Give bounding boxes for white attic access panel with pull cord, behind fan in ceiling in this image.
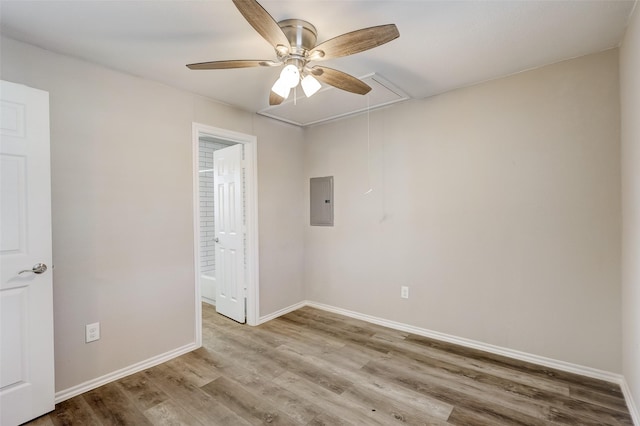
[258,73,409,126]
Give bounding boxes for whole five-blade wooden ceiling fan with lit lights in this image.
[187,0,400,105]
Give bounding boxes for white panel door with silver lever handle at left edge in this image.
[0,81,54,426]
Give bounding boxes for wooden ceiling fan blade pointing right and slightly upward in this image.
[309,24,400,61]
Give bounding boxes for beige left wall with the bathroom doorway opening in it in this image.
[1,39,303,391]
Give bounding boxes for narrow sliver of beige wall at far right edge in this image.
[620,3,640,415]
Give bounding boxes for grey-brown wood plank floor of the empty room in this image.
[29,305,632,426]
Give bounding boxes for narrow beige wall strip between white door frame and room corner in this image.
[255,116,304,316]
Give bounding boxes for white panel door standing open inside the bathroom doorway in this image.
[213,144,245,323]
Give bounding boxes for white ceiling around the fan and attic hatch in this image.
[0,0,635,112]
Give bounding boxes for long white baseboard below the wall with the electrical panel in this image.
[306,301,623,384]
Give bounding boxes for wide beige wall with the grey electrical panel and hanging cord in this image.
[305,50,621,372]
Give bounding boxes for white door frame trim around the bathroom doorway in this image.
[192,122,260,336]
